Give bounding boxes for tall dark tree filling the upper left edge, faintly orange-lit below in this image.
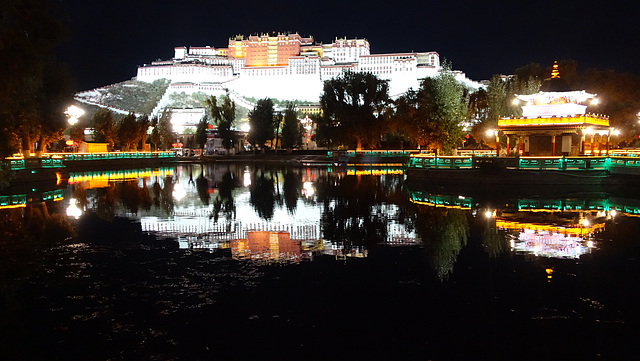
[0,0,73,157]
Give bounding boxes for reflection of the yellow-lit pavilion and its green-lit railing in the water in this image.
[410,191,624,258]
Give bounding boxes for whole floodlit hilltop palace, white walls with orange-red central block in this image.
[137,33,480,102]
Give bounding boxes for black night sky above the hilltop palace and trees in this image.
[50,0,640,90]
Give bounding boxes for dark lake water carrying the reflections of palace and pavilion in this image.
[0,165,640,360]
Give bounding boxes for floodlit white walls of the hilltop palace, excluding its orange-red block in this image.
[137,43,481,106]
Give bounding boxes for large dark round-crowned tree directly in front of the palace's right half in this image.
[316,72,390,150]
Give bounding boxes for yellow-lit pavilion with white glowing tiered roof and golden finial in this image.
[498,62,612,156]
